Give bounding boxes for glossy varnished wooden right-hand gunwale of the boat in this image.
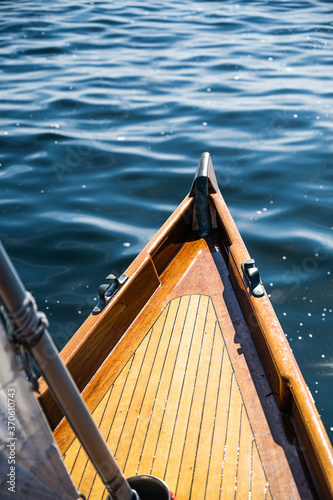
[210,189,333,499]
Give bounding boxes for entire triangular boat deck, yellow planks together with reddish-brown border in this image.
[55,236,313,500]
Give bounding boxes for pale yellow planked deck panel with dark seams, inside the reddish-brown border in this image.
[65,295,271,499]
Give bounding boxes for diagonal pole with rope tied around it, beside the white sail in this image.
[0,242,138,500]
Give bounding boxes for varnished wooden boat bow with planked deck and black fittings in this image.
[40,153,333,500]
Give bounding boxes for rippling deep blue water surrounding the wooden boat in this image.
[0,0,333,438]
